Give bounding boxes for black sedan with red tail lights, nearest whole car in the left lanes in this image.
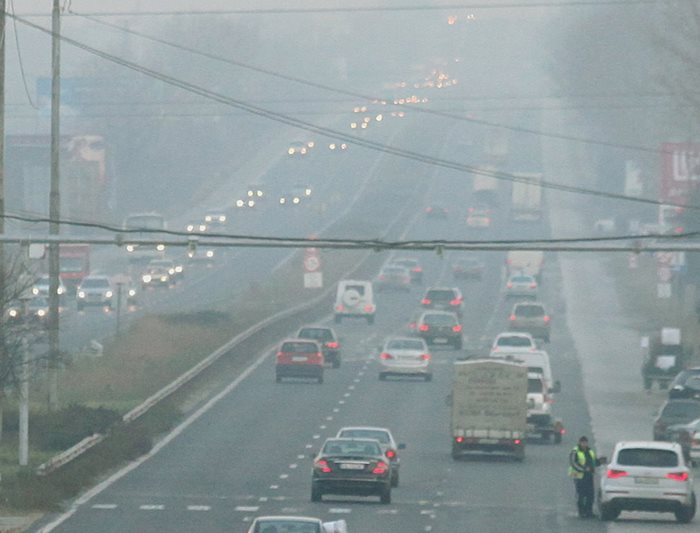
[311,439,391,504]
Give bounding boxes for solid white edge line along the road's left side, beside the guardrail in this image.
[39,340,272,533]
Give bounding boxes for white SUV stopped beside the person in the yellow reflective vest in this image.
[598,441,696,523]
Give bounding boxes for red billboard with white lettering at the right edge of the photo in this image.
[659,143,700,204]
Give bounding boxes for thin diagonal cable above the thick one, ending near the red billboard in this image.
[71,11,660,154]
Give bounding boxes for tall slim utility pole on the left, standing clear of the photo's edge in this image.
[48,0,61,411]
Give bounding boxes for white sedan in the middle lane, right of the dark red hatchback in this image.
[379,337,433,381]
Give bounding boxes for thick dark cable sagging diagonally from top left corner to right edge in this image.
[8,14,700,210]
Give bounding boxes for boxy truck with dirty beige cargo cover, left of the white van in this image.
[451,359,528,461]
